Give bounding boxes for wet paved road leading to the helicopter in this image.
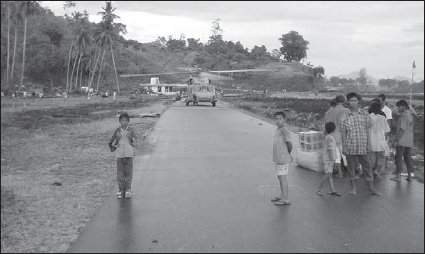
[69,99,424,252]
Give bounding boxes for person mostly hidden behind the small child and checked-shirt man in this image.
[324,94,350,178]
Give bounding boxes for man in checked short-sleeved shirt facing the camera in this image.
[340,92,382,196]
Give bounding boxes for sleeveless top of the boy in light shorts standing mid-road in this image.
[273,127,292,165]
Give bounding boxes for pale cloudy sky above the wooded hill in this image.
[41,1,424,82]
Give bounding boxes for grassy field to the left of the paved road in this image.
[1,96,173,253]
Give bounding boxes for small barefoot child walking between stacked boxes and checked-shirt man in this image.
[316,122,341,196]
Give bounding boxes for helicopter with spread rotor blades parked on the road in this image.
[120,67,270,107]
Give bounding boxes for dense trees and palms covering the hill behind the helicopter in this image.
[1,1,320,94]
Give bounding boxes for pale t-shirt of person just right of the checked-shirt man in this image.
[369,113,390,152]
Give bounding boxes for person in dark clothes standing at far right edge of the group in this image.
[390,100,413,182]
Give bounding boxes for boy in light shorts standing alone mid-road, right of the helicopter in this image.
[272,111,292,205]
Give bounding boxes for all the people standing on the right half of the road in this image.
[271,92,413,205]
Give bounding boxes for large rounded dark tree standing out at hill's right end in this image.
[279,31,310,62]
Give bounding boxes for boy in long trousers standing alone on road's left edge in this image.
[109,112,136,198]
